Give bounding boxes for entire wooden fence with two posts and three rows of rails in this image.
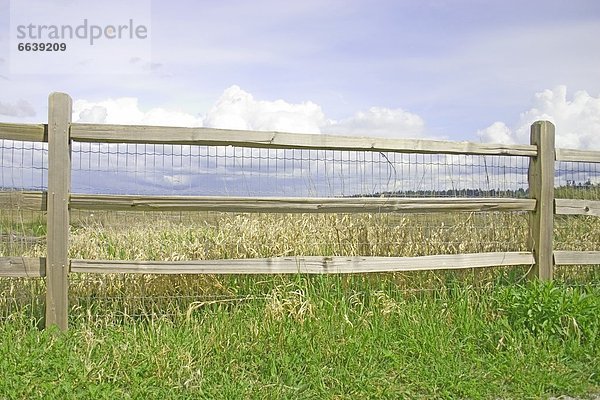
[0,93,600,329]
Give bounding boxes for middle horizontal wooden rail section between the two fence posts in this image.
[71,194,535,213]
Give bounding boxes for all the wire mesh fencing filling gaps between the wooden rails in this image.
[0,130,600,324]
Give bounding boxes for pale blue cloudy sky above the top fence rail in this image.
[0,0,600,148]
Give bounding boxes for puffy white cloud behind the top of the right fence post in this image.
[478,85,600,149]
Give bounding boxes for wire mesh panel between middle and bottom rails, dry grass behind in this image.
[70,212,528,261]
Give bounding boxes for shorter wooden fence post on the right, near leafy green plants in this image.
[529,121,555,281]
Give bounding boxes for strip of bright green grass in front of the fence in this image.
[0,276,600,399]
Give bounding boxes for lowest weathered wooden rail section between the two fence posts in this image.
[71,252,534,274]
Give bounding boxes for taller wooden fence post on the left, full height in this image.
[46,93,72,330]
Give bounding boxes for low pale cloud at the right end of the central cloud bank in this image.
[324,107,425,138]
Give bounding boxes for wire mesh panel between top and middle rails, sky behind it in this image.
[72,143,529,197]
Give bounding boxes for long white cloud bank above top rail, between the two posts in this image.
[73,85,425,141]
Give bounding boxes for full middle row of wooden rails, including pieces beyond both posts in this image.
[0,191,536,215]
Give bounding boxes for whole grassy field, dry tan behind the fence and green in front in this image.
[0,211,600,399]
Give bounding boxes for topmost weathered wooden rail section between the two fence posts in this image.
[71,124,537,156]
